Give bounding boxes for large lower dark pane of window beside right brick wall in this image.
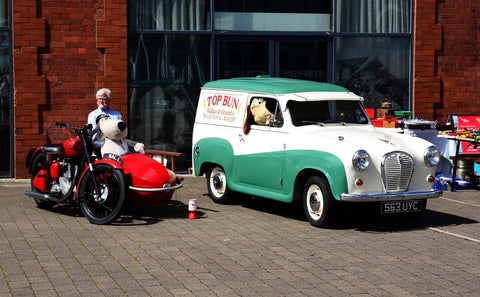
[336,37,410,110]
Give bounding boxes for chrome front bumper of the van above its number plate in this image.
[340,190,443,202]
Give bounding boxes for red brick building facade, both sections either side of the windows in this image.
[12,0,480,178]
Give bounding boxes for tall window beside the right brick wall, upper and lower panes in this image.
[335,0,411,110]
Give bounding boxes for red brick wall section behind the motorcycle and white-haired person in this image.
[12,0,128,178]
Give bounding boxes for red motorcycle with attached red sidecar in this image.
[25,122,183,224]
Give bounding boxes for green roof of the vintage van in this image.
[203,76,349,94]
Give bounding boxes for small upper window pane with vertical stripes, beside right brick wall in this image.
[337,0,410,33]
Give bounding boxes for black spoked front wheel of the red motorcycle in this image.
[79,164,127,225]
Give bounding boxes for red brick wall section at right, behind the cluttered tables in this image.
[413,0,480,121]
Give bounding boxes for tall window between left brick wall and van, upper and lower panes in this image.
[128,0,211,172]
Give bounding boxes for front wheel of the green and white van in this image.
[303,176,335,227]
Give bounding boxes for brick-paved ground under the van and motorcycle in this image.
[0,176,480,297]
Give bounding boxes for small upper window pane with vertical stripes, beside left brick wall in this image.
[128,0,210,30]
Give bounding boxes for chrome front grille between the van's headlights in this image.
[382,152,414,192]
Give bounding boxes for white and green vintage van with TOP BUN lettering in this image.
[192,77,442,227]
